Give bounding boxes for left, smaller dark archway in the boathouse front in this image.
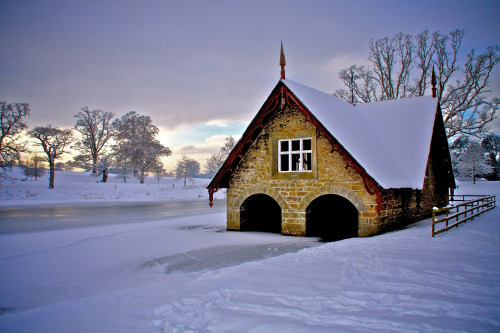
[240,194,281,233]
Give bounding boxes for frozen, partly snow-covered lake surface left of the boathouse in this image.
[0,200,320,326]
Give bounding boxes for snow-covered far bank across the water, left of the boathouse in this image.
[0,168,225,206]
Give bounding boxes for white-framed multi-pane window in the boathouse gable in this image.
[278,138,312,172]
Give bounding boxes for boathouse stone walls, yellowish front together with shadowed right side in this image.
[227,108,448,236]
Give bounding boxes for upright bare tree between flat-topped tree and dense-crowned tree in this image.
[74,106,115,175]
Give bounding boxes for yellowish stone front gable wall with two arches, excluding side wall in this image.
[227,108,379,236]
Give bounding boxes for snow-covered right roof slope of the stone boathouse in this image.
[282,79,438,189]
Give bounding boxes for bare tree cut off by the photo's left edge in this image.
[0,101,30,165]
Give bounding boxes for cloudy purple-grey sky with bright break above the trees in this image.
[0,0,500,170]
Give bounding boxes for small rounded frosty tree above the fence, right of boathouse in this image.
[457,141,492,184]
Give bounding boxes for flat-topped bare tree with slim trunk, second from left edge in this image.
[28,125,73,188]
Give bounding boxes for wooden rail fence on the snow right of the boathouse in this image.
[432,194,496,237]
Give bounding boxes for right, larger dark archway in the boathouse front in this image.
[306,194,358,242]
